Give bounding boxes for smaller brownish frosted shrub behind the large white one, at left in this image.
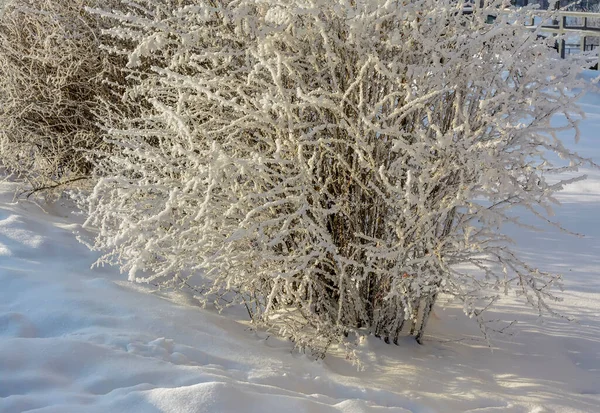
[0,0,124,194]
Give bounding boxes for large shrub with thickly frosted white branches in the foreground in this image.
[87,0,596,351]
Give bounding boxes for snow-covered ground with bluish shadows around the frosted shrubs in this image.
[0,96,600,413]
